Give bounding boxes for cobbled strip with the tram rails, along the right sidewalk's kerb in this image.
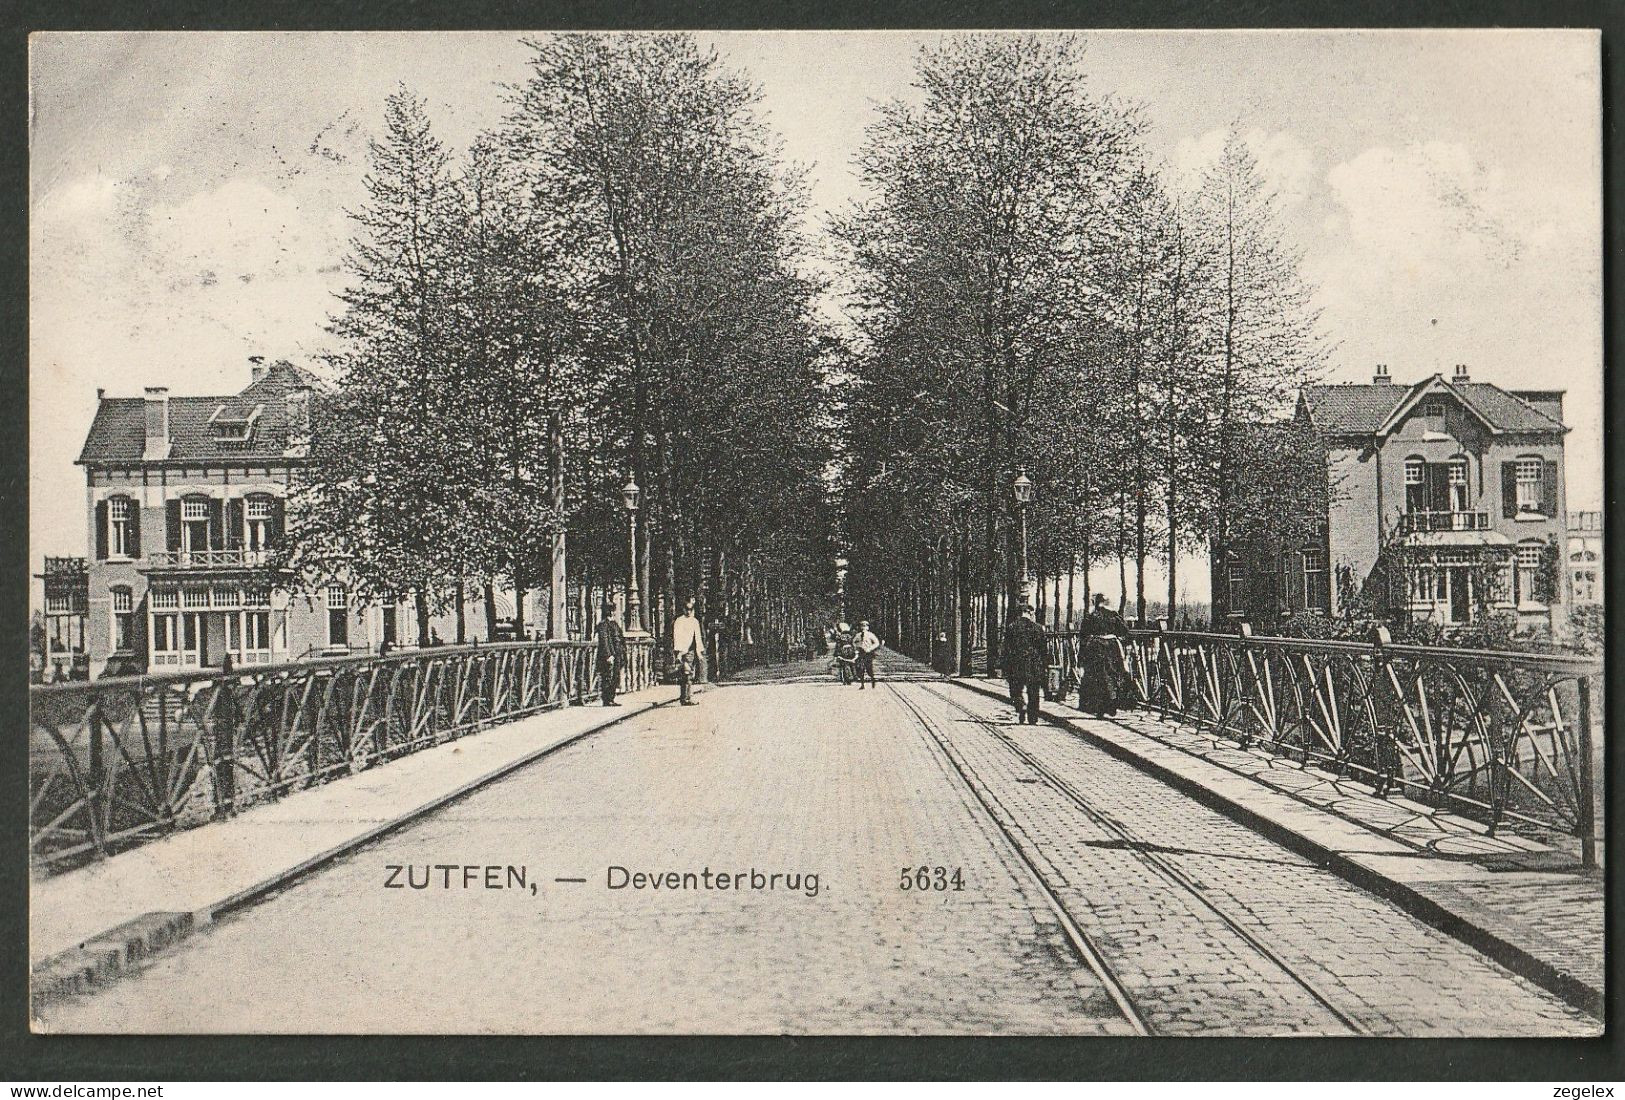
[904,684,1601,1037]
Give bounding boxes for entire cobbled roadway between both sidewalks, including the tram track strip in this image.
[42,660,1597,1035]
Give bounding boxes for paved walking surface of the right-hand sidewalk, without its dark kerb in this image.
[1098,708,1607,990]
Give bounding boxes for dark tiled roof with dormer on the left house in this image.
[78,362,322,465]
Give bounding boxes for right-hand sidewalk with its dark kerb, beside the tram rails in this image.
[954,679,1604,1017]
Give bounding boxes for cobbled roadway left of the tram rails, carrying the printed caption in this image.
[34,656,1128,1035]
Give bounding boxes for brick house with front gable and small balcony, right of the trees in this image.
[1222,366,1571,630]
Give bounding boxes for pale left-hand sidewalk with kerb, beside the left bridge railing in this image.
[29,686,689,998]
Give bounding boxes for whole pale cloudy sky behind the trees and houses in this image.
[29,31,1602,598]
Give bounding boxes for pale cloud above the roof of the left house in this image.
[29,171,349,565]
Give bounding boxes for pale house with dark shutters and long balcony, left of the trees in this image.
[78,359,425,676]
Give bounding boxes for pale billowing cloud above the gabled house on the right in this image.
[1307,134,1602,507]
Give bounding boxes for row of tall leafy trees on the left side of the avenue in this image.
[288,34,835,640]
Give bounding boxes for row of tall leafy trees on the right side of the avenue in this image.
[837,36,1324,669]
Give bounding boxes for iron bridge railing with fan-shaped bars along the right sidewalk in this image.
[1050,629,1602,864]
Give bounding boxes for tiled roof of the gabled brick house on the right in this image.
[1302,374,1568,435]
